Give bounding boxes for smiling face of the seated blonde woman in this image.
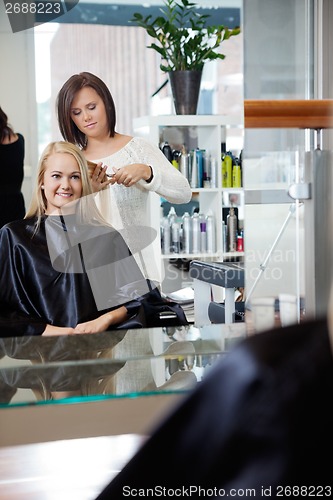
[42,153,82,215]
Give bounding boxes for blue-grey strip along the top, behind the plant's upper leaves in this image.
[57,0,241,28]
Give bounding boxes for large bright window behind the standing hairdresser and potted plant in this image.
[35,0,243,148]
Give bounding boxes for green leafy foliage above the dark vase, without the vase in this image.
[131,0,240,72]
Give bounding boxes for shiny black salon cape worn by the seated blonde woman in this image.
[0,216,149,337]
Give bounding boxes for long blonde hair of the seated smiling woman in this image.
[24,141,106,232]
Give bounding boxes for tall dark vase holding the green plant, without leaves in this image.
[169,70,202,115]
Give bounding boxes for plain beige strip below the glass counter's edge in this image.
[0,392,186,446]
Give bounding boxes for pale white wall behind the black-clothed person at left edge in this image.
[0,2,38,205]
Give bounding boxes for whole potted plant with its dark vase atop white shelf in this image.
[132,0,240,114]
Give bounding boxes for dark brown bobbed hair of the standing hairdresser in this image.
[56,71,116,148]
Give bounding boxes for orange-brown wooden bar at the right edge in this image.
[244,99,333,129]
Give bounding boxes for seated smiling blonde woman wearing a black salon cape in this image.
[0,141,147,336]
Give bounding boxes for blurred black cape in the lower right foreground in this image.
[97,320,333,500]
